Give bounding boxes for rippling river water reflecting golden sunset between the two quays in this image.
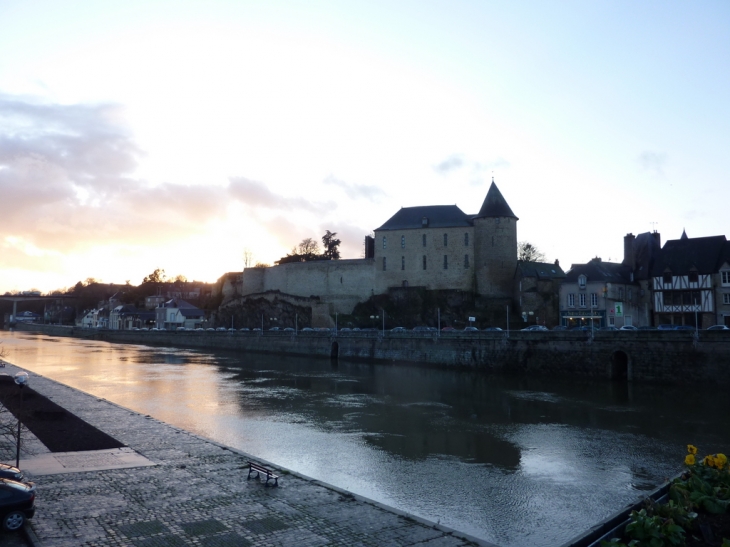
[0,332,730,547]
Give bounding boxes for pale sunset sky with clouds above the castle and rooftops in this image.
[0,0,730,293]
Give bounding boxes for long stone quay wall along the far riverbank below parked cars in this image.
[18,324,730,385]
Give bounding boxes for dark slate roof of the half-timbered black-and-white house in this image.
[652,236,730,277]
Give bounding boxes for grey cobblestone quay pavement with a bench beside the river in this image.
[0,365,488,547]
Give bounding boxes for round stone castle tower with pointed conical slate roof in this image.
[473,179,519,298]
